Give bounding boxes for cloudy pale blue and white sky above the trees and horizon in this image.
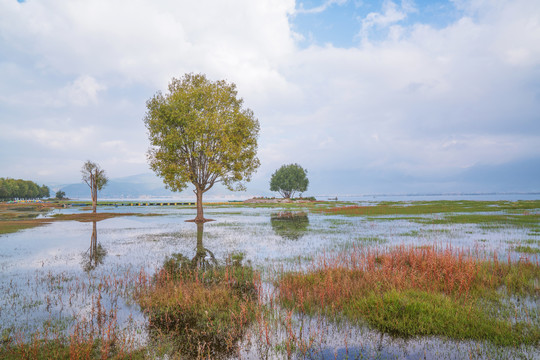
[0,0,540,194]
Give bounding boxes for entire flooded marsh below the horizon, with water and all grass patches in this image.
[0,201,540,359]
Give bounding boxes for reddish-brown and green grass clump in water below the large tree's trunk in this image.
[136,253,260,359]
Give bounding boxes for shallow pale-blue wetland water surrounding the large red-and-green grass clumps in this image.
[0,201,540,359]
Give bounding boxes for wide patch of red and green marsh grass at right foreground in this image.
[276,246,540,346]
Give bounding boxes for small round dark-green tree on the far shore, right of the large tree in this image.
[270,164,309,199]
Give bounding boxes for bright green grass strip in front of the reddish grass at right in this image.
[343,289,528,345]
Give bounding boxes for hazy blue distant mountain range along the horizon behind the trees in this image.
[50,158,540,200]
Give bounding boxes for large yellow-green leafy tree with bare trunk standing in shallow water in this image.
[144,74,259,222]
